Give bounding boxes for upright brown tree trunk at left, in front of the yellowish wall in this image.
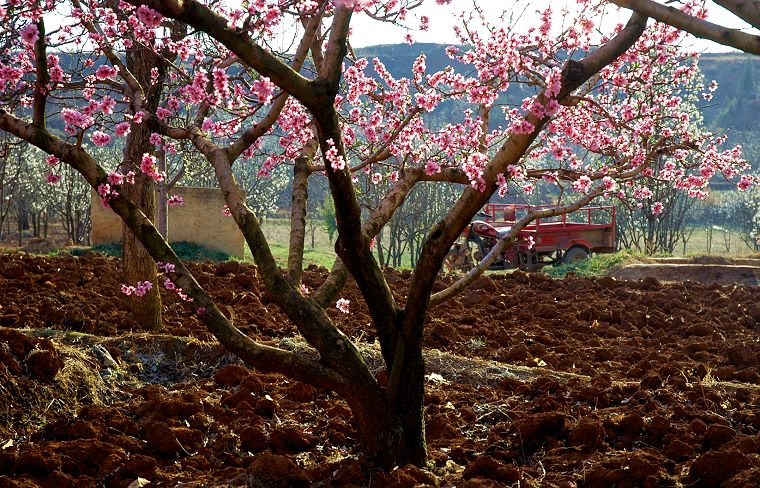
[122,43,165,331]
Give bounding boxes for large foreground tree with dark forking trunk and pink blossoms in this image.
[0,0,752,468]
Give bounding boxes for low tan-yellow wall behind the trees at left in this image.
[92,187,245,258]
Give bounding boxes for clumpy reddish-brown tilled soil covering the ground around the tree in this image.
[0,254,760,488]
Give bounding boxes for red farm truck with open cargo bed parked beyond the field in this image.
[445,203,616,271]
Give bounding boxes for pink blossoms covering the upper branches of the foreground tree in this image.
[0,0,757,254]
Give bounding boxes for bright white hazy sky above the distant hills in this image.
[351,0,748,52]
